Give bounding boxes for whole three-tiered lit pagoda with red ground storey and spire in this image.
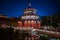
[18,3,41,29]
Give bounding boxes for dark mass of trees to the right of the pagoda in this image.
[42,13,60,28]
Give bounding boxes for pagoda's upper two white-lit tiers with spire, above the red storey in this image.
[21,3,39,20]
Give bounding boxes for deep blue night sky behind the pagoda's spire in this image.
[0,0,60,17]
